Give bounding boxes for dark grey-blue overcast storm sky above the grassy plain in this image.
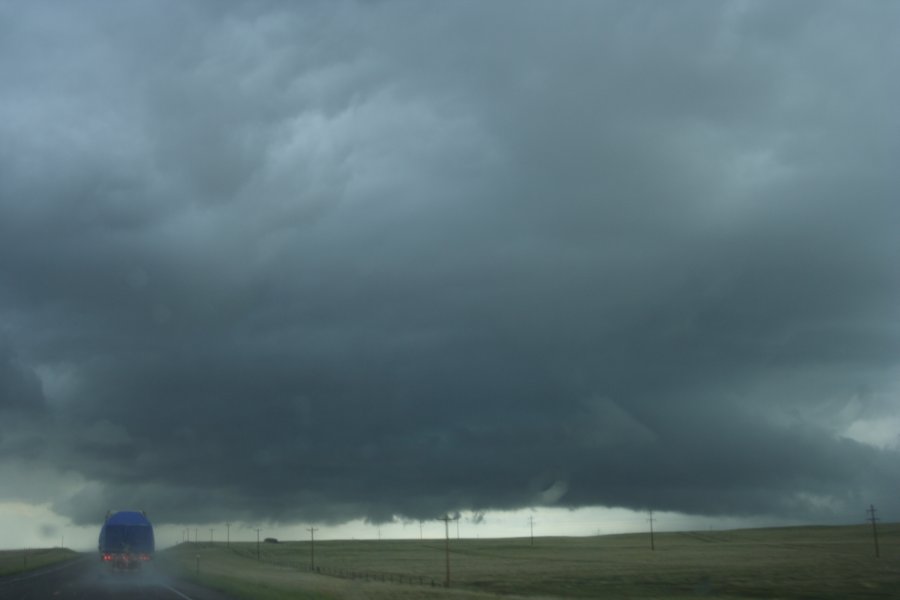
[0,0,900,544]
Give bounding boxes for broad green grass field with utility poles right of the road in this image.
[157,524,900,600]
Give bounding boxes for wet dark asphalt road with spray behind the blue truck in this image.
[0,554,232,600]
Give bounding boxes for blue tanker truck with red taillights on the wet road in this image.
[98,510,154,571]
